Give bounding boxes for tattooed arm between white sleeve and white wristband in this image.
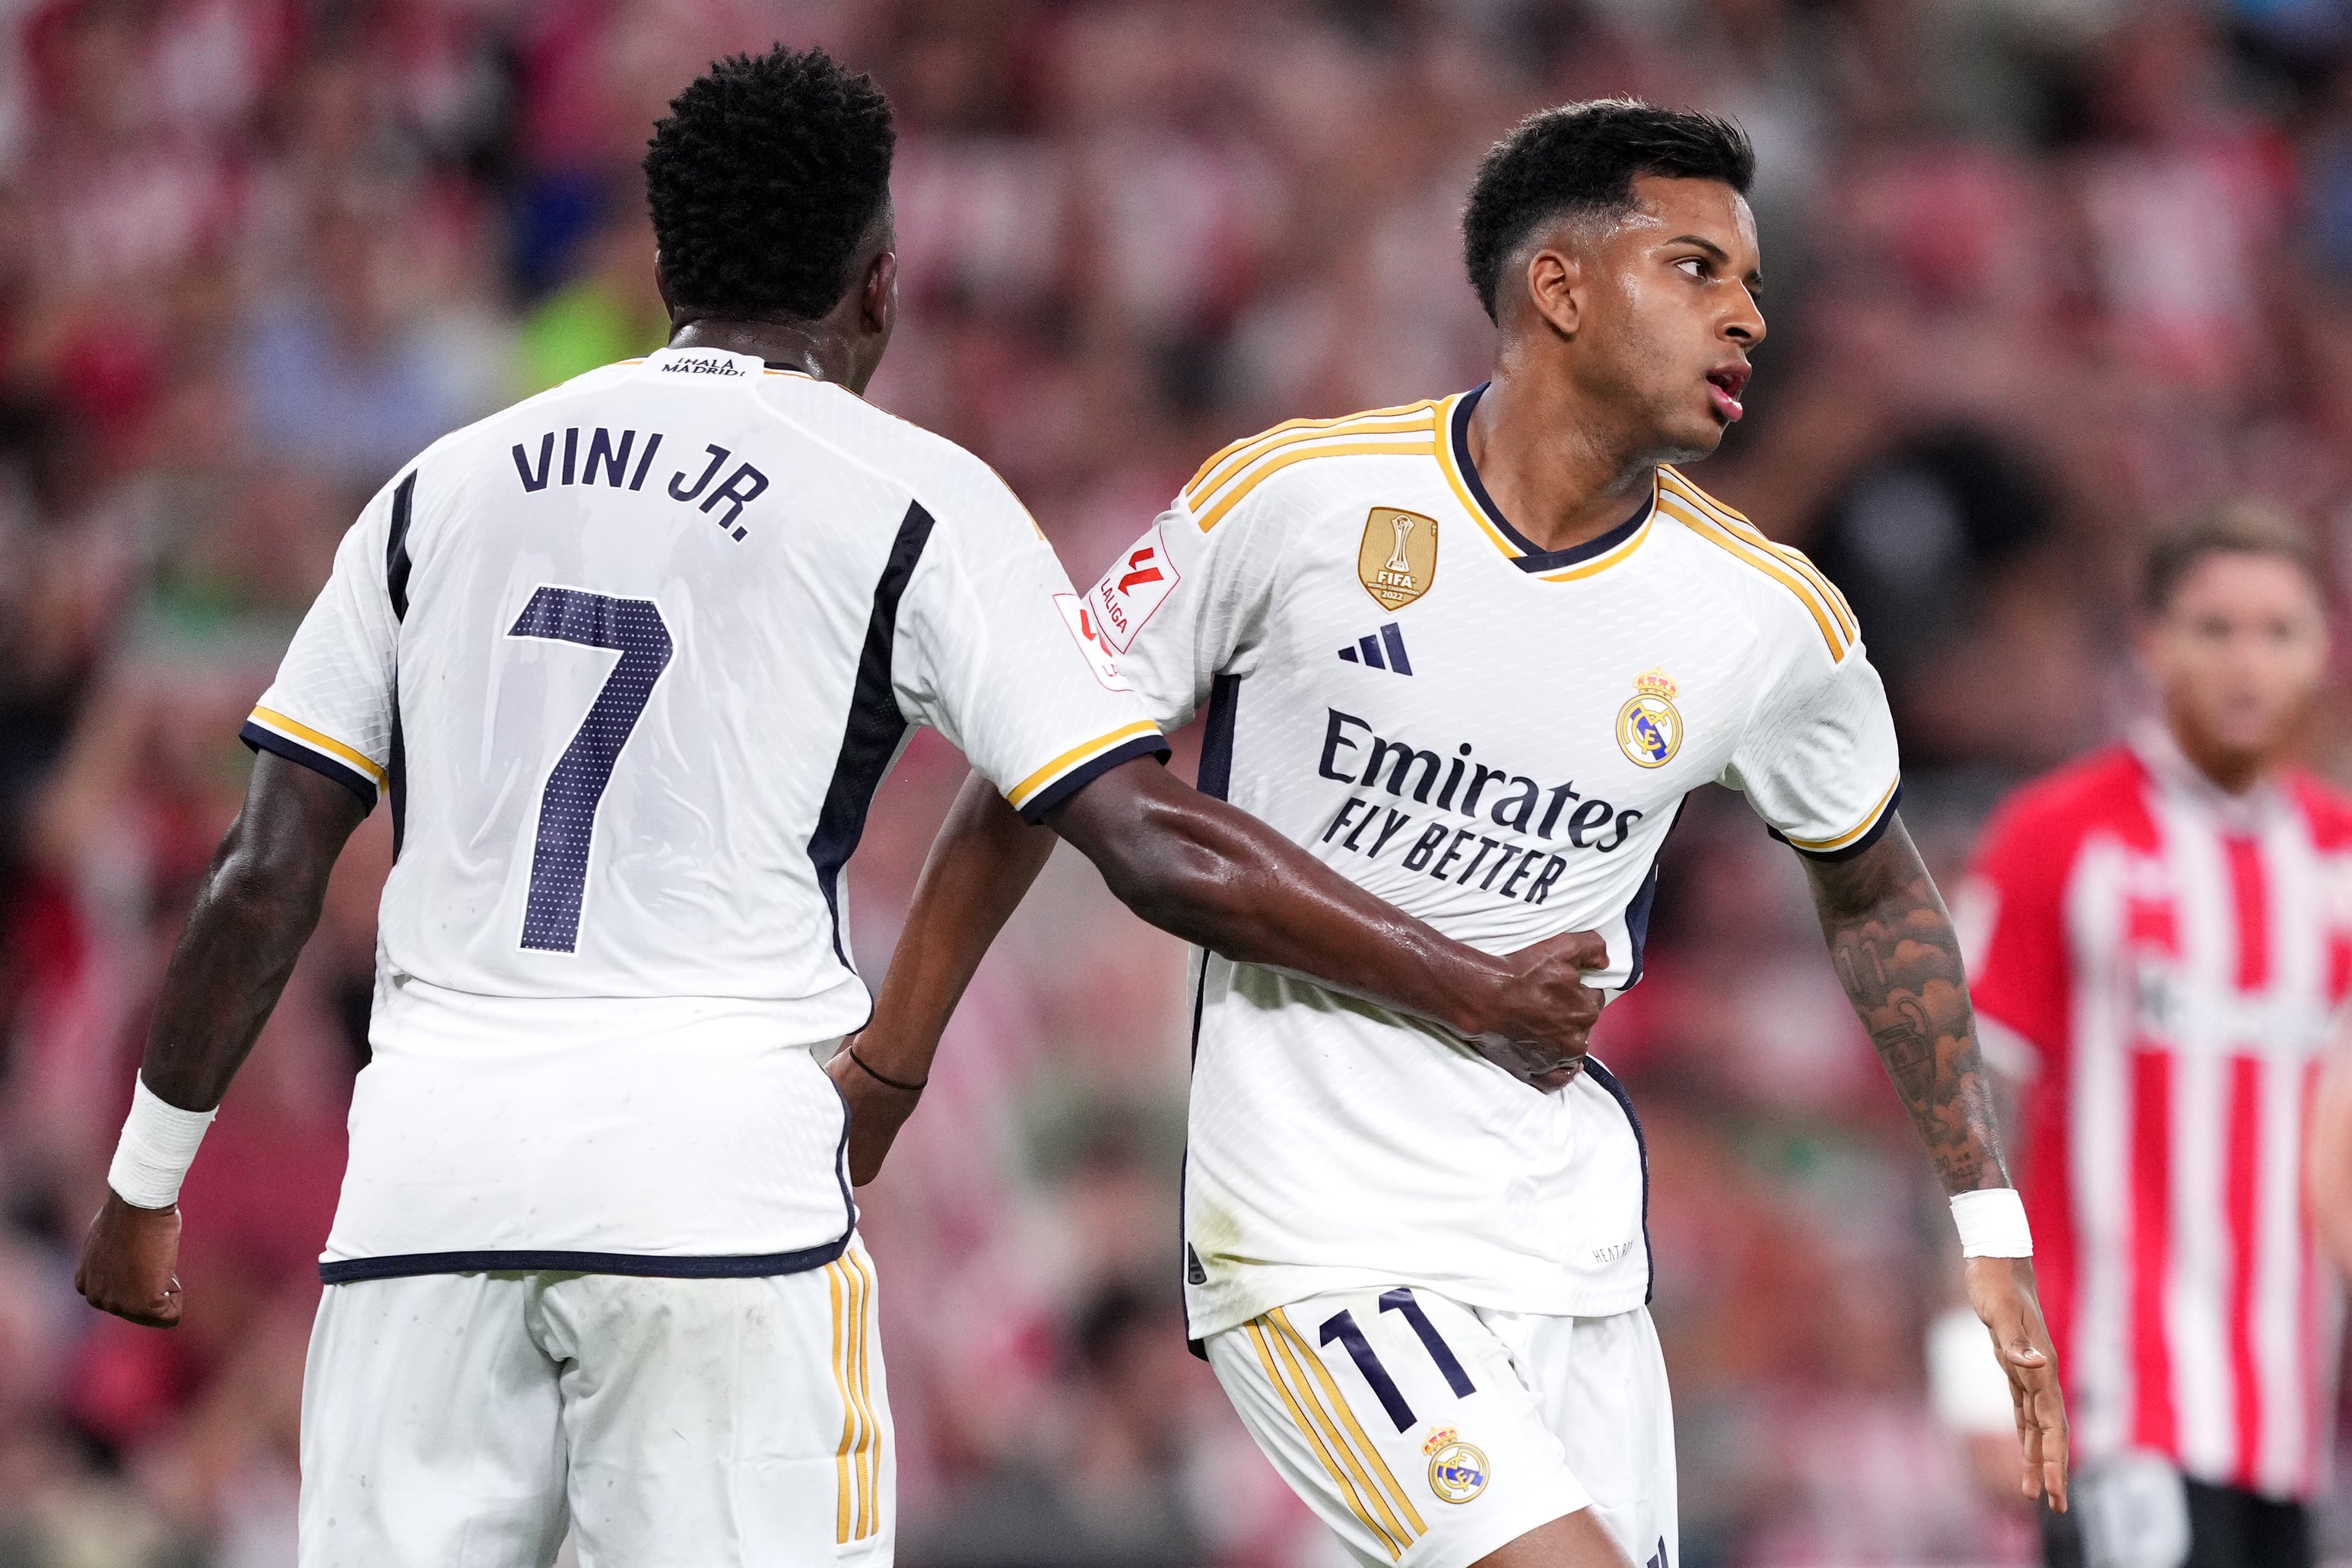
[1806,823,2006,1192]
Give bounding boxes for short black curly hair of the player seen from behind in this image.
[644,45,899,319]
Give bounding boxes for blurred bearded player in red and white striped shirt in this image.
[1954,503,2352,1568]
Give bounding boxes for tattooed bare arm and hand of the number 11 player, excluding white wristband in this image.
[1804,818,2068,1509]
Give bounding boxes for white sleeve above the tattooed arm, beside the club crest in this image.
[1722,637,1903,860]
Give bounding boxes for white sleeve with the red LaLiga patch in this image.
[1084,496,1282,728]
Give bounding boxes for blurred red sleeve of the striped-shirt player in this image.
[1954,808,2074,1077]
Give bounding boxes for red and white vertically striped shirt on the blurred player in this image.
[1962,731,2352,1497]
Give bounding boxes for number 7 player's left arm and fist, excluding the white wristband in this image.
[73,752,367,1328]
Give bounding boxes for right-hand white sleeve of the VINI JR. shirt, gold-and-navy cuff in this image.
[891,475,1169,821]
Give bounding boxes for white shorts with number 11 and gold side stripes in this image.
[1209,1286,1681,1568]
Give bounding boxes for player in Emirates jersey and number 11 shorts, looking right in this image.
[852,101,2065,1568]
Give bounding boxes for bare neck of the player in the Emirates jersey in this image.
[1470,369,1658,552]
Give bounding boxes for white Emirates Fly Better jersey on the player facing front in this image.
[1082,392,1896,1338]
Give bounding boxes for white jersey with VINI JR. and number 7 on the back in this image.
[245,351,1162,1284]
